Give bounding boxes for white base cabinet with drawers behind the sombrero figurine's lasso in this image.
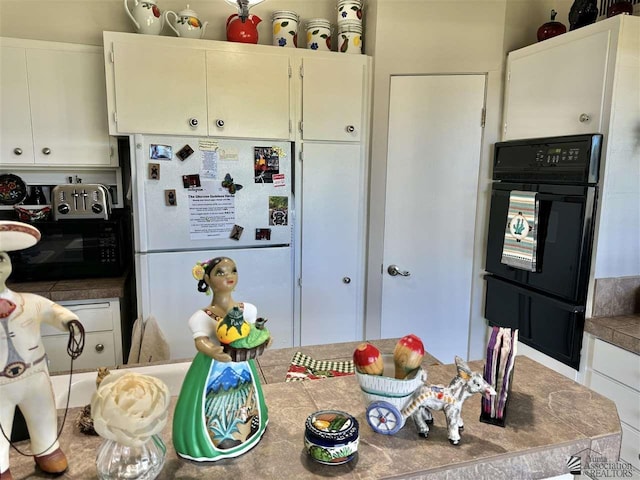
[41,299,122,372]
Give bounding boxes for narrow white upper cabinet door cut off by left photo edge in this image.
[0,46,33,165]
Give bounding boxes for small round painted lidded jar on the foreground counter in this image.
[304,410,359,465]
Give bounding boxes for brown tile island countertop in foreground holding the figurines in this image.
[11,340,621,480]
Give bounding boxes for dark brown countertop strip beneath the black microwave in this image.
[7,275,127,302]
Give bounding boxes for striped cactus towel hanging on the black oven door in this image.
[501,190,538,272]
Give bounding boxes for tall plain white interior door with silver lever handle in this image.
[381,75,485,363]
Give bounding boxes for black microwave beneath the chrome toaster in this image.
[9,209,132,282]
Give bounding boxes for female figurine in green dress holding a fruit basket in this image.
[173,257,271,461]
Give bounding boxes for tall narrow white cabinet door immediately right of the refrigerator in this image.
[300,143,365,345]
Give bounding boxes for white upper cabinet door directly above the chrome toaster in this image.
[27,49,111,166]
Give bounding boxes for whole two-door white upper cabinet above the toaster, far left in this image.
[0,39,117,167]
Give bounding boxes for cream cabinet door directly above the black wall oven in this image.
[503,31,610,140]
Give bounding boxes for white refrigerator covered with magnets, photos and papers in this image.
[131,135,294,359]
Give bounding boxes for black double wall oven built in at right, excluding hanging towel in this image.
[485,134,602,370]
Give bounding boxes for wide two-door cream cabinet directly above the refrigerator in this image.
[104,32,292,140]
